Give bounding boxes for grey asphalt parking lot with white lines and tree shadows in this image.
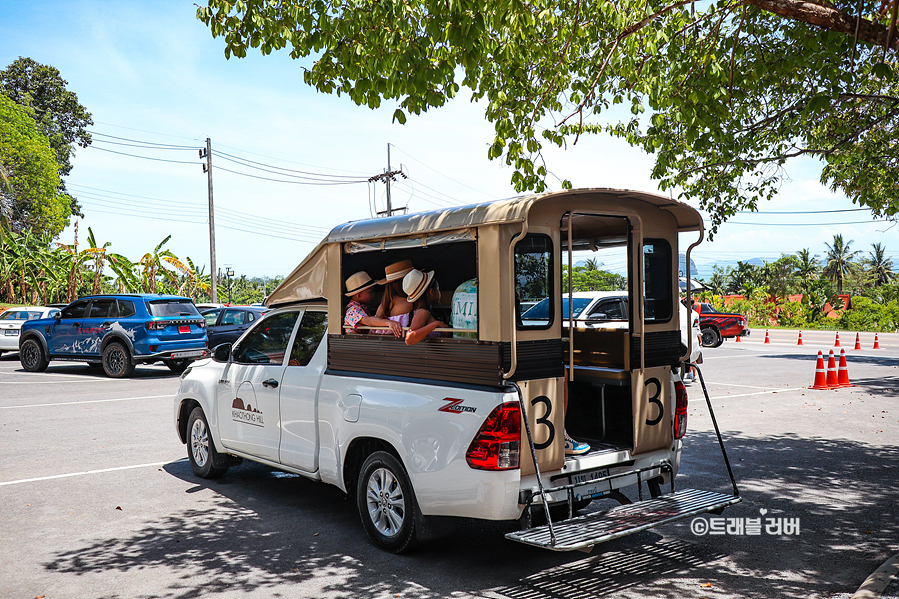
[0,330,899,599]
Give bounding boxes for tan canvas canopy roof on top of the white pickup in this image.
[266,188,703,306]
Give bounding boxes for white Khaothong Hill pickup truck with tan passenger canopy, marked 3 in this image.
[174,190,740,552]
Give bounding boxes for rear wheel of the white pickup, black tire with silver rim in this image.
[356,451,418,553]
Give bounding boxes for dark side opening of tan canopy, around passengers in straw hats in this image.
[341,240,478,338]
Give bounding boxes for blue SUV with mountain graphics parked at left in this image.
[19,294,208,378]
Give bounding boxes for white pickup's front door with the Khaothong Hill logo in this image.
[216,312,298,462]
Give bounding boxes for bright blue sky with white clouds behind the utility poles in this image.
[0,0,899,277]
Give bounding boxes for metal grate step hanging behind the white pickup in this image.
[506,489,741,551]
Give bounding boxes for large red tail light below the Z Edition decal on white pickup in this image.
[465,403,521,470]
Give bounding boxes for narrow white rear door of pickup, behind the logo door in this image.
[281,307,328,472]
